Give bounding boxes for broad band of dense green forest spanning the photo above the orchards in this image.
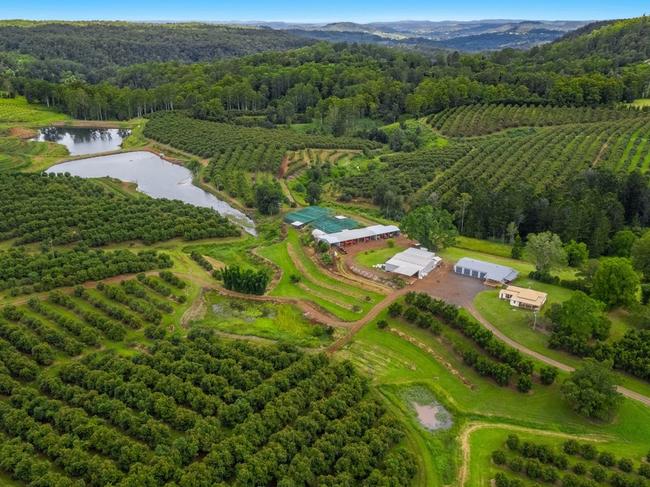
[0,18,650,123]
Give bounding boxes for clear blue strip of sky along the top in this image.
[0,0,650,22]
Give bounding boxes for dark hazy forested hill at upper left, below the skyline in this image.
[0,21,310,81]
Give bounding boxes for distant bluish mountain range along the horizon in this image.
[233,19,589,51]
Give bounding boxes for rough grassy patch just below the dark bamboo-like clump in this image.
[195,292,330,347]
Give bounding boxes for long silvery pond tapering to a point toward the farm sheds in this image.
[47,151,255,235]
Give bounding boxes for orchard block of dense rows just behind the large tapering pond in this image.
[144,113,377,173]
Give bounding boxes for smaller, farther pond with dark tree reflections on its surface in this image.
[33,127,131,156]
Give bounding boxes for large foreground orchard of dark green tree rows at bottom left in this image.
[0,310,415,487]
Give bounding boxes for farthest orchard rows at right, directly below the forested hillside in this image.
[428,104,650,137]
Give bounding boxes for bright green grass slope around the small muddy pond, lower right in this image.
[340,314,650,487]
